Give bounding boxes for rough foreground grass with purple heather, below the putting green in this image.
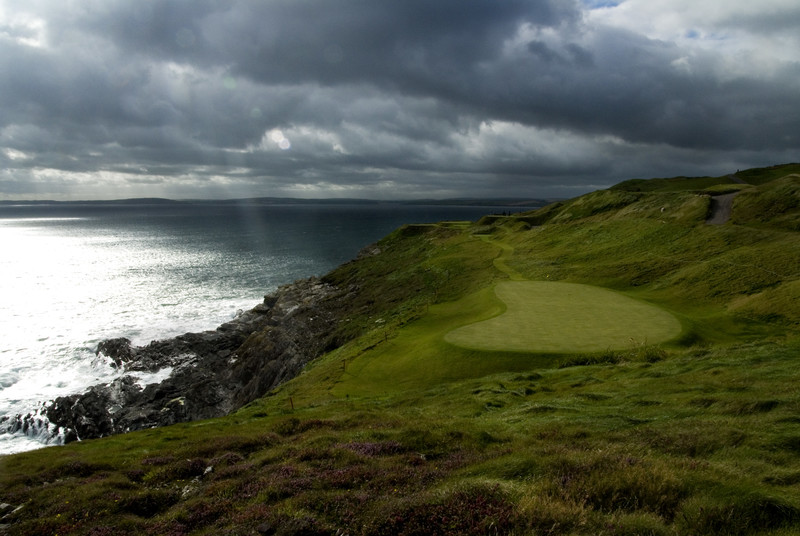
[0,343,800,535]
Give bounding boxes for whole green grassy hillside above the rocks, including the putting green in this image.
[0,165,800,535]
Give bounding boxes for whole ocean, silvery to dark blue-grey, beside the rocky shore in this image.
[0,203,506,454]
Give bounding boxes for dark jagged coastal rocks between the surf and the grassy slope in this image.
[46,278,348,442]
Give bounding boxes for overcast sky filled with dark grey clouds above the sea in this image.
[0,0,800,199]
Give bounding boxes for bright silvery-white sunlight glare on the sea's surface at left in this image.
[0,220,258,422]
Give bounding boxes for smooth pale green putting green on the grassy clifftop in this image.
[445,281,681,353]
